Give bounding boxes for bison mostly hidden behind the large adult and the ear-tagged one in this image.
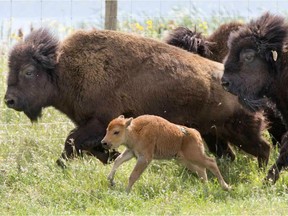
[165,22,287,147]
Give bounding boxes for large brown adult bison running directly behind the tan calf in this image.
[5,29,270,165]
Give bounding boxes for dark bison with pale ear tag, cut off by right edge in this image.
[222,13,288,182]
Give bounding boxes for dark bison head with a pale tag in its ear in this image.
[222,13,288,111]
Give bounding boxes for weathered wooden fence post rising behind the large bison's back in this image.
[105,0,118,30]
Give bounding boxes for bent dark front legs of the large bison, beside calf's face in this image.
[57,120,119,166]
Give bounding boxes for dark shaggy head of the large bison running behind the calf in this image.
[5,29,59,121]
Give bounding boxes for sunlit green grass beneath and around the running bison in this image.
[0,30,288,215]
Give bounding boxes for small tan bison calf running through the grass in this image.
[101,115,230,192]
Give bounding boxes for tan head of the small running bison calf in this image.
[101,115,133,149]
